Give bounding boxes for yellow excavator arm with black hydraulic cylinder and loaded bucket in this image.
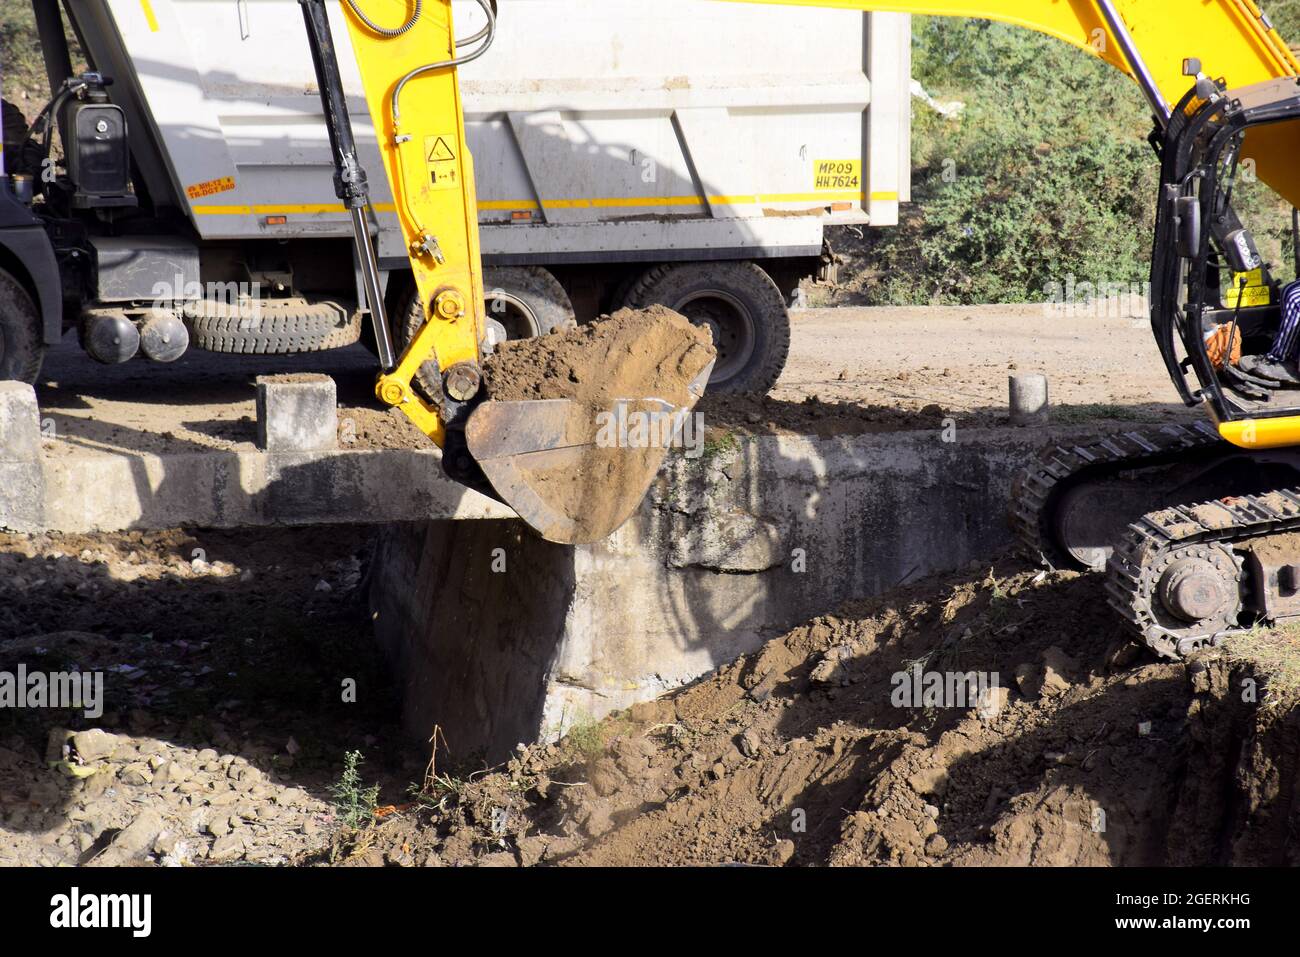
[300,0,714,544]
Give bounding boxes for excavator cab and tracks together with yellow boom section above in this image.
[761,0,1300,657]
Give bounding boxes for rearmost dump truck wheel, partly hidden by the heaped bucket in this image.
[625,263,790,394]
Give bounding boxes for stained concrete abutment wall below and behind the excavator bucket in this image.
[372,429,1093,759]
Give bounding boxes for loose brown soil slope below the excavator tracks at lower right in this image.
[325,562,1297,865]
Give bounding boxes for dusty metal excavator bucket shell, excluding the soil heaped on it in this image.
[465,358,714,545]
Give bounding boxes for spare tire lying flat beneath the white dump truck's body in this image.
[182,298,361,355]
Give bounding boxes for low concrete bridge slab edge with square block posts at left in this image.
[0,376,515,533]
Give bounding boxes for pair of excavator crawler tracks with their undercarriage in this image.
[1011,423,1300,657]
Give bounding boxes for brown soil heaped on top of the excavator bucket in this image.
[484,306,716,408]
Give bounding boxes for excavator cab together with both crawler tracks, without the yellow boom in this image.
[1013,27,1300,657]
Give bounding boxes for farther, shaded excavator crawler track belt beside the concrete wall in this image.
[1010,421,1230,568]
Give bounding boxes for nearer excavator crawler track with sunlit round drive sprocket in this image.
[1106,488,1300,658]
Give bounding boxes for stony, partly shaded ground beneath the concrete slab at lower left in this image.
[0,528,423,865]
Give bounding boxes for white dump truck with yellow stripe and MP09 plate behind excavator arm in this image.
[0,0,910,391]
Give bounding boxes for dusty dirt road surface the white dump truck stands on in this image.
[30,306,1187,460]
